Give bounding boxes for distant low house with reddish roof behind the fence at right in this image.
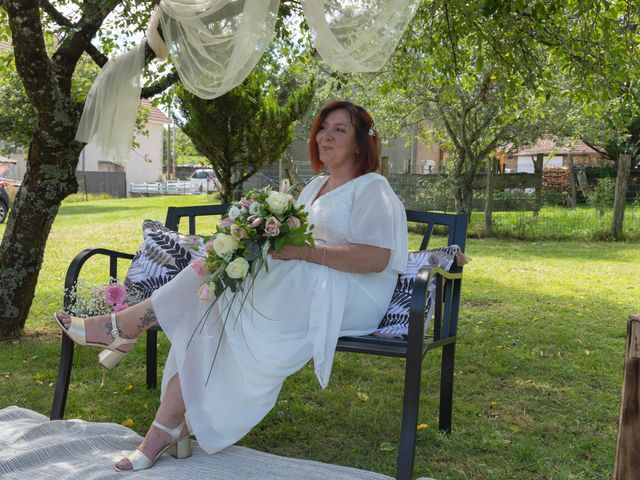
[499,137,613,173]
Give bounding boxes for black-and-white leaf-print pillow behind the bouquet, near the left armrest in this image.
[124,220,205,300]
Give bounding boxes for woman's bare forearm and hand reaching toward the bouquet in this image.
[271,243,391,273]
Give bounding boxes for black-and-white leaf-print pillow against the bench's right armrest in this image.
[373,245,460,338]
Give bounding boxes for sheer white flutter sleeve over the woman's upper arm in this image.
[347,176,408,273]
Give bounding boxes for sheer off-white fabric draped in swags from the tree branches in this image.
[76,0,419,164]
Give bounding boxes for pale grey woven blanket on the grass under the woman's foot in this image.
[0,407,436,480]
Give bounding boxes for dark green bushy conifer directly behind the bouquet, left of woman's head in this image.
[175,66,315,202]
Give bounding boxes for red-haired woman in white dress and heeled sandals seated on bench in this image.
[56,101,407,470]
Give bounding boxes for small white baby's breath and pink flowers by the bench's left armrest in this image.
[67,281,140,317]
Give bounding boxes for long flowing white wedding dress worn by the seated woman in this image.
[152,173,407,453]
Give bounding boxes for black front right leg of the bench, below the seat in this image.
[396,355,422,480]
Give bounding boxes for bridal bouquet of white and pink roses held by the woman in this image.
[191,186,313,302]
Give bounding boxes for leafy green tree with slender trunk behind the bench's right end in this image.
[356,0,549,211]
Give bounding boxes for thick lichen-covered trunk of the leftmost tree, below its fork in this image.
[0,130,82,338]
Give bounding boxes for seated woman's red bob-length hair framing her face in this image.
[309,100,380,177]
